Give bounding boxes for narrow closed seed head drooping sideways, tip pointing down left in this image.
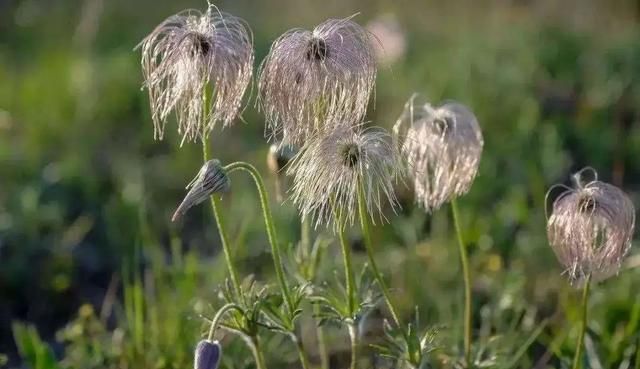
[171,159,231,221]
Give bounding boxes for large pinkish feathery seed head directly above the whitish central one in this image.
[258,17,376,145]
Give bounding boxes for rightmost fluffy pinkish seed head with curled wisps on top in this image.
[547,168,635,284]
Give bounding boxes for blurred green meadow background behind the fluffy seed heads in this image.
[0,0,640,368]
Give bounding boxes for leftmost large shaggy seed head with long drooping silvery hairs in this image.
[138,5,254,142]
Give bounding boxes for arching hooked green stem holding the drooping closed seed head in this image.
[225,161,293,314]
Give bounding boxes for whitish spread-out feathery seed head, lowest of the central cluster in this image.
[287,126,401,228]
